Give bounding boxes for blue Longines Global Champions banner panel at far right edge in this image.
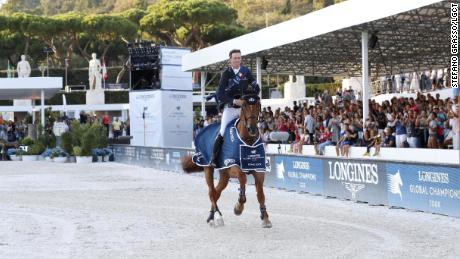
[386,163,460,217]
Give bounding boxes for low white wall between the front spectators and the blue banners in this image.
[266,144,460,165]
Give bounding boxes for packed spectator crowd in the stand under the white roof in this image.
[194,90,459,156]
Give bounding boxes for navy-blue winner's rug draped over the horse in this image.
[193,118,265,172]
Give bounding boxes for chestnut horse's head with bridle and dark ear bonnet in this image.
[241,94,260,137]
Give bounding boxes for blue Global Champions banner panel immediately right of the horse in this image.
[267,156,323,194]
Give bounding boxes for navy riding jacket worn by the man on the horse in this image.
[216,66,260,108]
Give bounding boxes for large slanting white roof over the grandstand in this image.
[182,0,450,76]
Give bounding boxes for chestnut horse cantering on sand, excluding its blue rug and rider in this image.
[182,95,272,228]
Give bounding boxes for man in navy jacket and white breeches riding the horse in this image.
[210,49,260,167]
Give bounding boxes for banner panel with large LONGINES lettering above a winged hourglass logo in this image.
[323,158,388,205]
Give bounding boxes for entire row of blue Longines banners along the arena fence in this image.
[114,145,460,217]
